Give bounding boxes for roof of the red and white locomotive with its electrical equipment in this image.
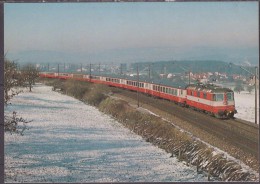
[186,83,233,93]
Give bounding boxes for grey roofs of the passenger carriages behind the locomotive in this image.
[93,74,188,89]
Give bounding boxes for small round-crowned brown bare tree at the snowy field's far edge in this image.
[21,64,39,92]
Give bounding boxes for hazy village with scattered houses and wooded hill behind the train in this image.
[18,61,259,93]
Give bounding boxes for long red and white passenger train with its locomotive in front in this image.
[39,72,237,119]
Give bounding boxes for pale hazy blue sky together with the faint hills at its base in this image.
[4,2,259,63]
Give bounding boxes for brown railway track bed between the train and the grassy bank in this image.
[115,90,259,158]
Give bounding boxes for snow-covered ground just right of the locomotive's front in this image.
[234,91,259,124]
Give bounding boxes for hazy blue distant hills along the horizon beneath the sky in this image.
[7,46,259,66]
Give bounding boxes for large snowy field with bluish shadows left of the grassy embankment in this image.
[5,85,207,183]
